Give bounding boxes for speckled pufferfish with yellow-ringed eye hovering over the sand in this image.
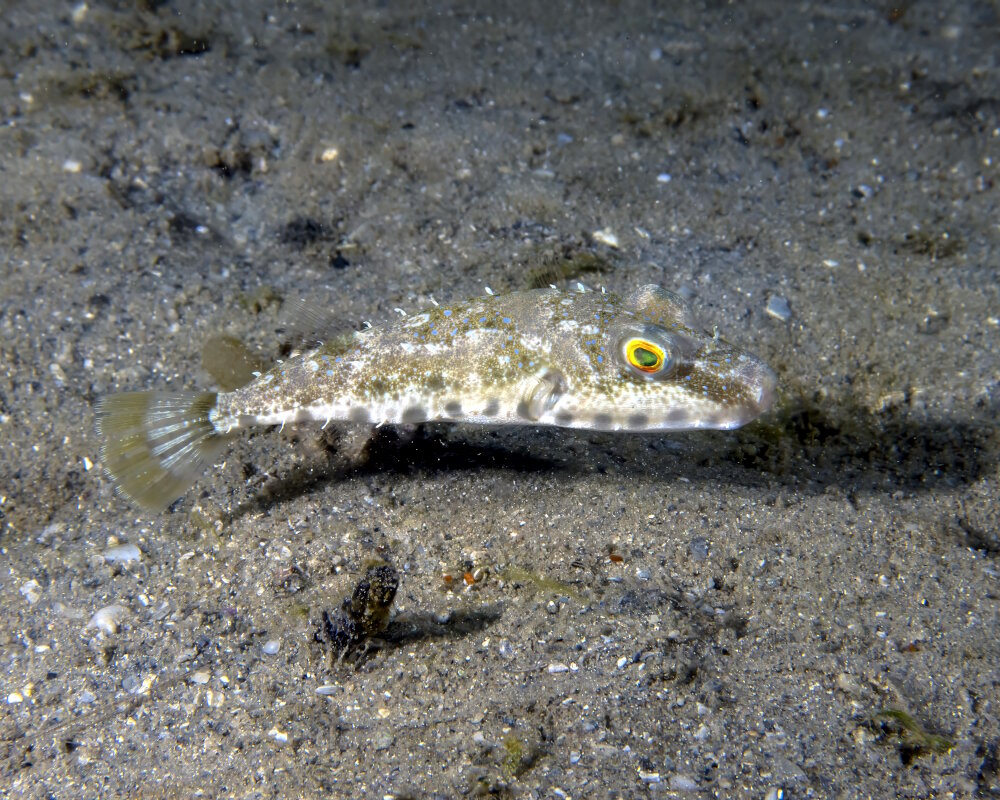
[96,285,776,509]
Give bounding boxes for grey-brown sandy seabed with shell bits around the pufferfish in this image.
[0,0,1000,800]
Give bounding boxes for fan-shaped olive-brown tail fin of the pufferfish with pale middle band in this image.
[95,392,228,510]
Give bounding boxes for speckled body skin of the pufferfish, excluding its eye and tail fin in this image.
[212,286,774,431]
